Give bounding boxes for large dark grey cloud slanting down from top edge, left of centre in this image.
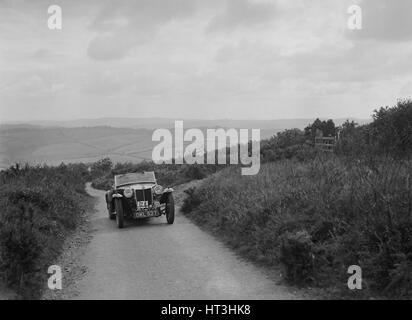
[87,0,197,60]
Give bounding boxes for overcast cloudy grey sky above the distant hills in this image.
[0,0,412,121]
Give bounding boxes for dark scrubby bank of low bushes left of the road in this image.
[0,164,91,299]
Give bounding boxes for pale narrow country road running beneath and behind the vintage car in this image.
[54,182,299,299]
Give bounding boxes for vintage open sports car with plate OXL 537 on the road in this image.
[106,172,175,228]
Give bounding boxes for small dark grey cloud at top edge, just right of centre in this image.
[207,0,276,32]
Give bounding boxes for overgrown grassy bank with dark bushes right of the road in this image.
[182,101,412,298]
